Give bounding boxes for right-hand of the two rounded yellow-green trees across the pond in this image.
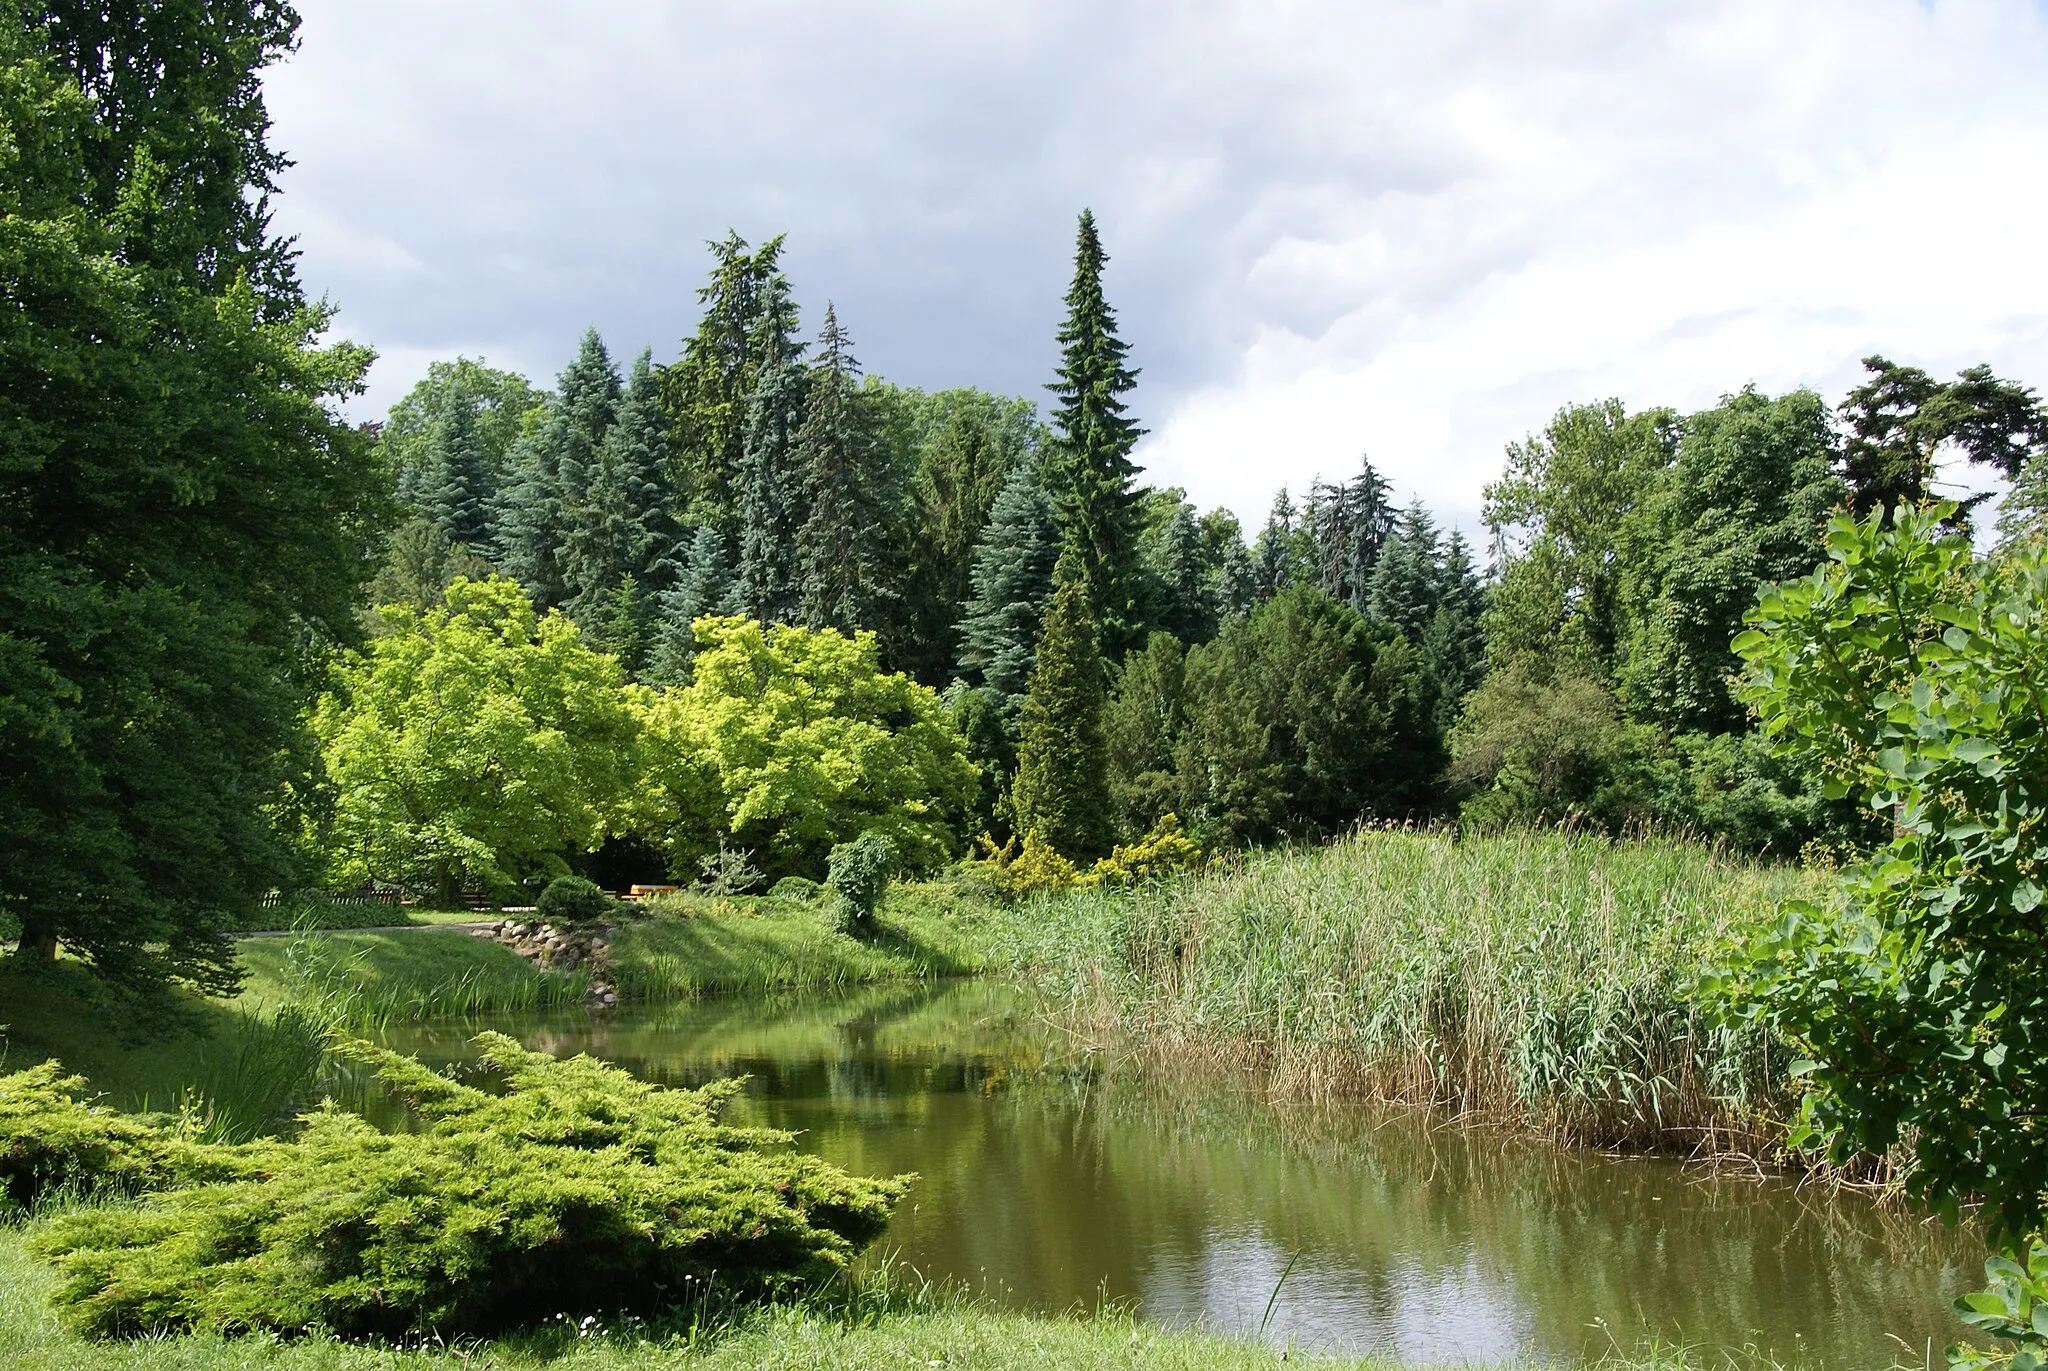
[639,617,977,879]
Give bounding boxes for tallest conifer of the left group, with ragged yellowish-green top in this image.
[662,230,797,541]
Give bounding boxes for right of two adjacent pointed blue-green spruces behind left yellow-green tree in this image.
[561,352,676,643]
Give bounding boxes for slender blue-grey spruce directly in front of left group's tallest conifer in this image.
[733,348,811,623]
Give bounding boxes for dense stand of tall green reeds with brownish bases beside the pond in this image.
[993,832,1812,1150]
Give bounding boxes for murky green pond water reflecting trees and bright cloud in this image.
[376,982,1982,1367]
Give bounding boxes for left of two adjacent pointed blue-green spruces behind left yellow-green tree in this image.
[498,328,623,609]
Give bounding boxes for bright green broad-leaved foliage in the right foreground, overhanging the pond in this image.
[1714,504,2048,1365]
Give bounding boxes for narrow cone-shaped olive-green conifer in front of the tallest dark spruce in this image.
[1010,549,1114,861]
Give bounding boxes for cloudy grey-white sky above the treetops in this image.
[266,0,2048,531]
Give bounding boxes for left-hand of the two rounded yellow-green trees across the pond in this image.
[313,578,637,906]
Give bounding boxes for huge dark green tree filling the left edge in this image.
[0,13,393,988]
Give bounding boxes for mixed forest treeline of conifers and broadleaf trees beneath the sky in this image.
[371,215,2048,877]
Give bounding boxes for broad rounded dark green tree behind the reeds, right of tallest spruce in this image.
[1178,584,1442,842]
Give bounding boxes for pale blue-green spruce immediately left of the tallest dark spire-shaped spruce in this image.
[961,461,1059,721]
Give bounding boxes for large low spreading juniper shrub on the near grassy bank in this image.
[33,1033,909,1336]
